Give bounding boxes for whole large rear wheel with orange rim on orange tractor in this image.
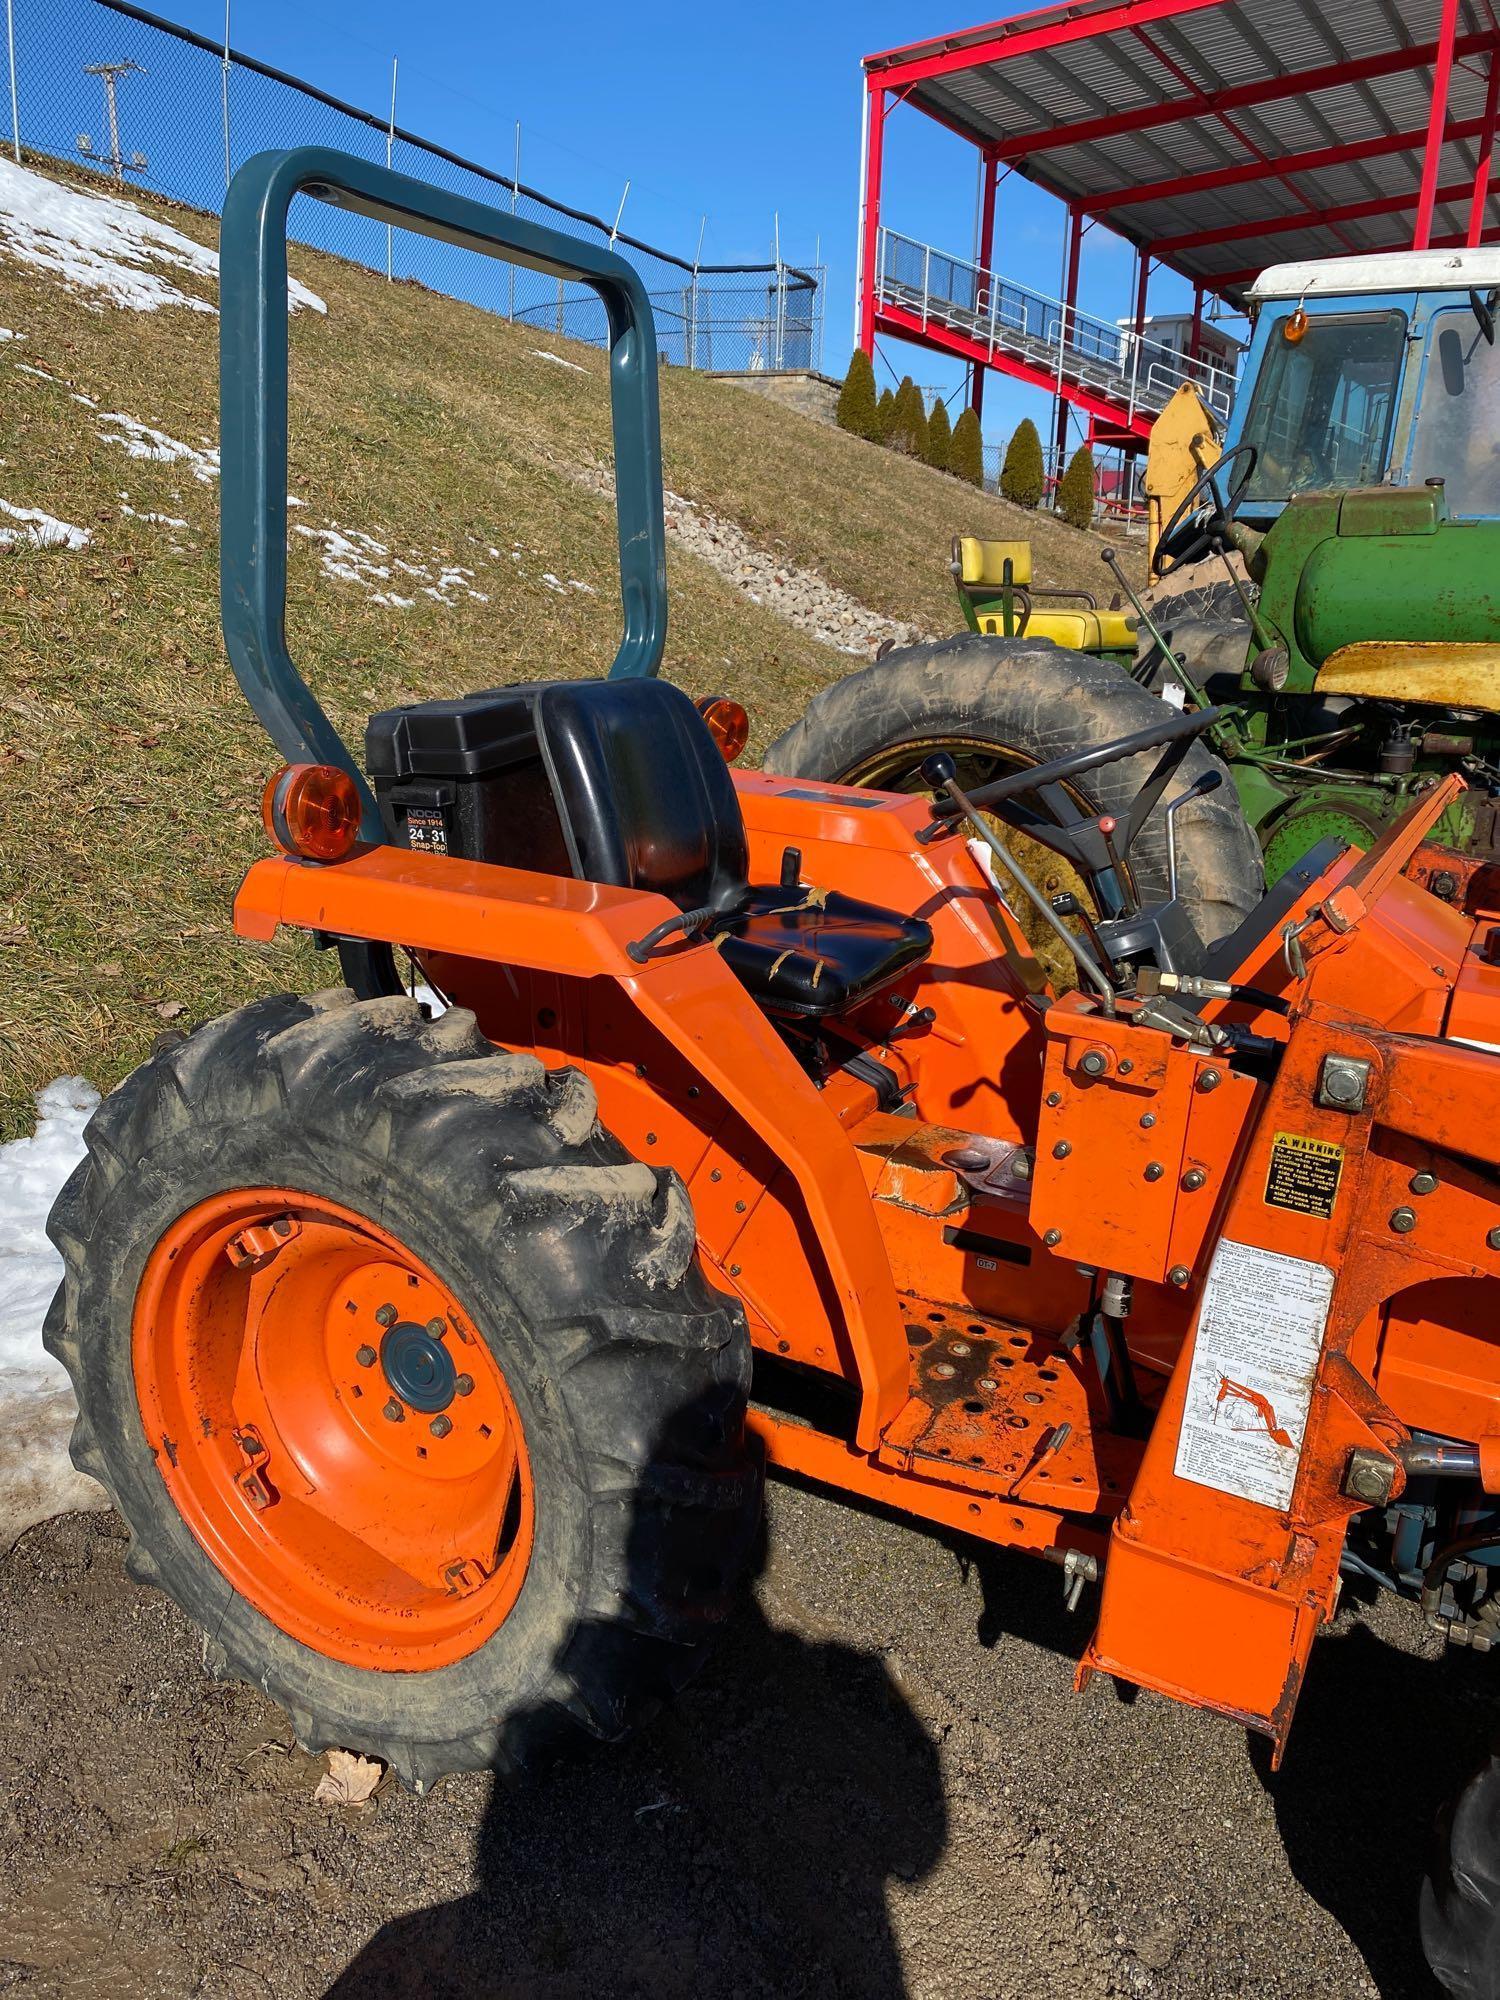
[46,988,762,1790]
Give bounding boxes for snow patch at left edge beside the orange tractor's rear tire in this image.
[0,1076,108,1554]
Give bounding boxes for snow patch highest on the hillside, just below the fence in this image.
[0,160,328,312]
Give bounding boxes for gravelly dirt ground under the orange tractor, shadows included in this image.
[0,1486,1488,2000]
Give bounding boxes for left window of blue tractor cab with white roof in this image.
[1240,308,1406,502]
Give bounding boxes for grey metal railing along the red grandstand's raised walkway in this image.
[876,228,1234,420]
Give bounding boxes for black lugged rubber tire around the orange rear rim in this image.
[46,988,760,1788]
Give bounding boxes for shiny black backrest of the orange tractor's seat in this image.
[536,680,748,910]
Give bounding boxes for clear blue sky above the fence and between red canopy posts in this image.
[47,0,1224,440]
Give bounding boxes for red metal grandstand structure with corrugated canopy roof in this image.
[858,0,1500,460]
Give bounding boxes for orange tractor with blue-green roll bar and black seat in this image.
[48,152,1500,1996]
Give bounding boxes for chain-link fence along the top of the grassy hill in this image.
[0,0,822,372]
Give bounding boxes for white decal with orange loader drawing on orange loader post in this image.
[1172,1240,1338,1510]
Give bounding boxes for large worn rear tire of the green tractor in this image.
[766,634,1264,946]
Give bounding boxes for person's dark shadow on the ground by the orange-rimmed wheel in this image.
[328,1496,948,2000]
